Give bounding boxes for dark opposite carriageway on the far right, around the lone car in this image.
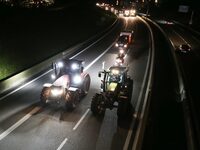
[159,24,200,146]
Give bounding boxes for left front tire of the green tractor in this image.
[91,93,106,116]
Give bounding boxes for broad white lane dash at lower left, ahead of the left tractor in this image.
[0,107,41,141]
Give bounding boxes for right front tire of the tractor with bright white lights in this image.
[64,90,80,110]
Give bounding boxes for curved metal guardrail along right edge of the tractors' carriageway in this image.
[132,16,155,150]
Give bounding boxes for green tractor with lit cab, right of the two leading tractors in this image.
[91,66,133,117]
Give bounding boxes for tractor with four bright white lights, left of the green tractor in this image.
[40,59,90,109]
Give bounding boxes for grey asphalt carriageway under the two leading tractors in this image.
[0,18,149,150]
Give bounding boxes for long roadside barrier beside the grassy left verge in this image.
[0,19,118,94]
